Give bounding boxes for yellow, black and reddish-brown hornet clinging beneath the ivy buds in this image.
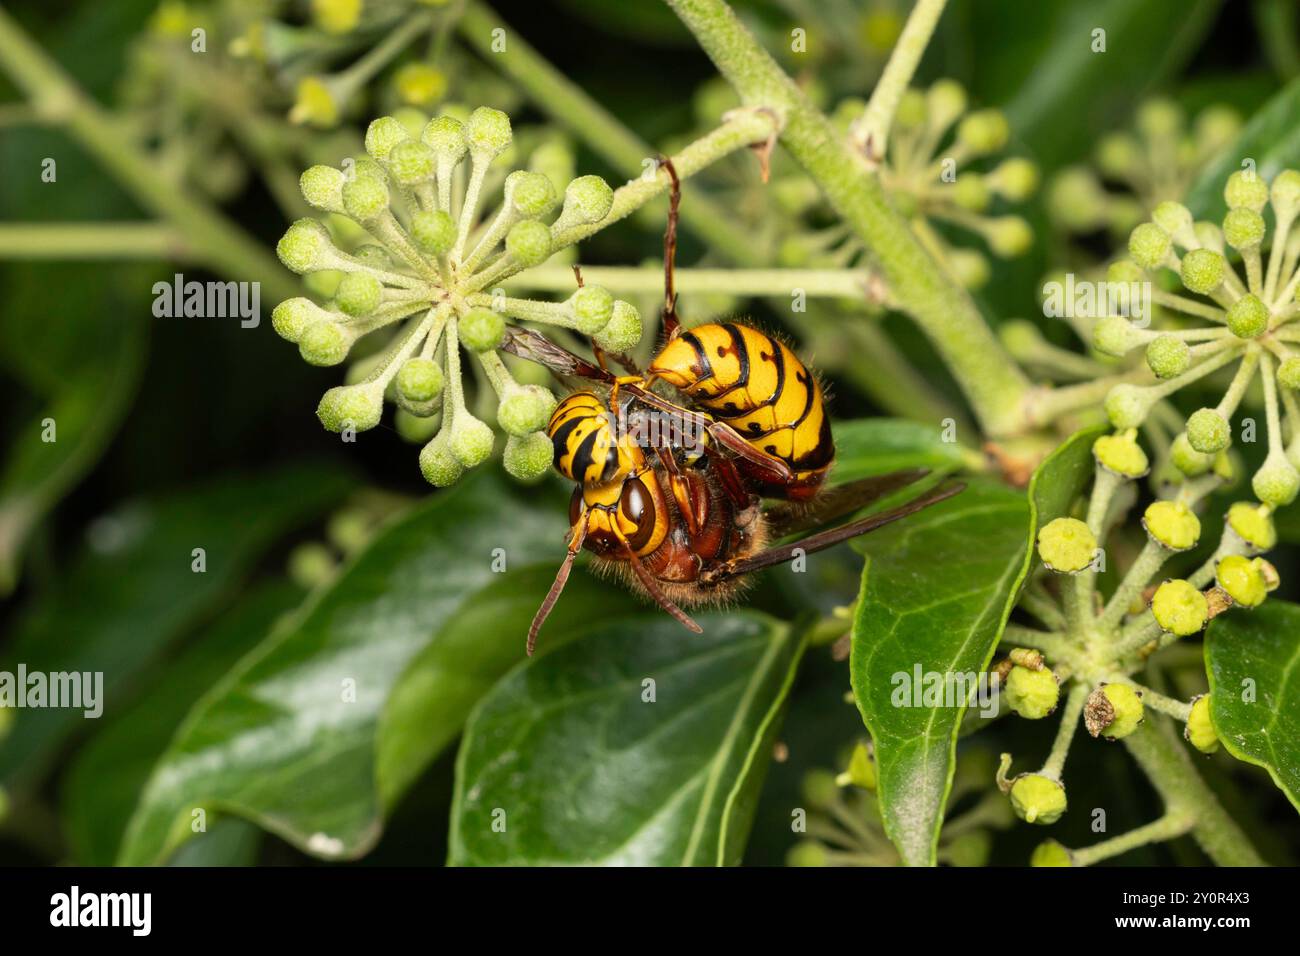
[503,160,963,654]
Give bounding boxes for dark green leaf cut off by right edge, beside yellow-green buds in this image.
[1205,598,1300,810]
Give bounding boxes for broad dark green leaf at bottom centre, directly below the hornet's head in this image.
[449,611,803,866]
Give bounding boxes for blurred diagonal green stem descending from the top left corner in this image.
[0,9,300,299]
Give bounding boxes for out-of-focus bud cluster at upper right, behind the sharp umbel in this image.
[1047,99,1242,240]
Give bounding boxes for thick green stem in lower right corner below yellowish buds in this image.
[1123,718,1264,866]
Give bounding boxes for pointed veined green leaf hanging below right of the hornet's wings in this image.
[850,429,1102,865]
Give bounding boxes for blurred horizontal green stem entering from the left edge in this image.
[0,222,194,260]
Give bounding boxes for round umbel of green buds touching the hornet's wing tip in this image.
[272,107,641,485]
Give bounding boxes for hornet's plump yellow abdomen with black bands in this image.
[647,323,835,498]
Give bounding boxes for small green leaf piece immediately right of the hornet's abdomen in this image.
[831,419,965,484]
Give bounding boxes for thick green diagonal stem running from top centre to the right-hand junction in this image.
[668,0,1030,436]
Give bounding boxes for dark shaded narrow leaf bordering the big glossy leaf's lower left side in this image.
[62,581,303,866]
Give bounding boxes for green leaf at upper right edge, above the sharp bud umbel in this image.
[1187,79,1300,222]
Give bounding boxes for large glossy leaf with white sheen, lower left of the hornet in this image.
[118,470,569,864]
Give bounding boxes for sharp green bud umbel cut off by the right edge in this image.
[1095,169,1300,507]
